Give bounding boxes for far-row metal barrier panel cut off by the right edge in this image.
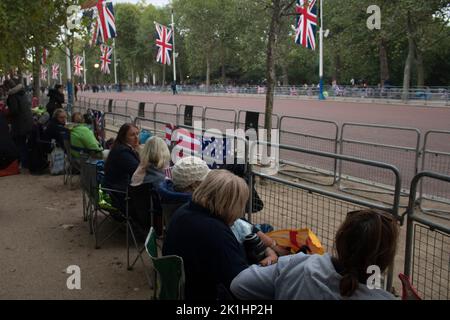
[420,131,450,219]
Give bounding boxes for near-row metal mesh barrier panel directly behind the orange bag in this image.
[249,142,401,287]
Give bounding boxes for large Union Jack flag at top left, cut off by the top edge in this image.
[94,0,117,43]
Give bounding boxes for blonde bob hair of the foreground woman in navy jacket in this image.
[192,170,250,226]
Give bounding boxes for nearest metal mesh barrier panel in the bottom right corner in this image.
[404,172,450,300]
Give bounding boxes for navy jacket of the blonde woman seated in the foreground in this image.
[163,202,248,301]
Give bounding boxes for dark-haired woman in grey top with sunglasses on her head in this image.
[231,210,399,300]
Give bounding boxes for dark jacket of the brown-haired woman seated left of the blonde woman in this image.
[103,144,139,191]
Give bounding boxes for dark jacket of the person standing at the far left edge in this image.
[6,84,33,137]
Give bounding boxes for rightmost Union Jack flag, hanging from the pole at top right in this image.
[295,0,317,50]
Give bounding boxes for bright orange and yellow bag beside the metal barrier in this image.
[267,229,325,255]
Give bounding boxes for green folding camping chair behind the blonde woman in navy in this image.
[145,227,185,300]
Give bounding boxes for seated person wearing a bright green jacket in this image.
[70,112,103,158]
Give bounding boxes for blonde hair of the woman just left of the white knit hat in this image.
[141,137,170,170]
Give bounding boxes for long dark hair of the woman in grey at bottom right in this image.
[335,210,398,297]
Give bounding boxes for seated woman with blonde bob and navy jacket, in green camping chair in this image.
[163,170,249,300]
